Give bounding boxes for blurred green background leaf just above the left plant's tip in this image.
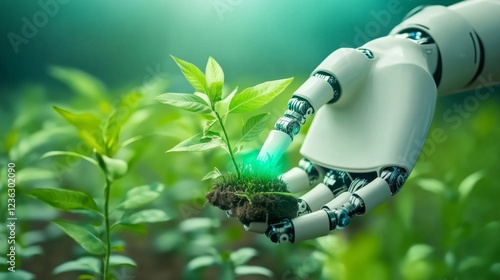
[49,66,106,101]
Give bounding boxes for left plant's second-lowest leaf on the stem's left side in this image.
[53,221,106,255]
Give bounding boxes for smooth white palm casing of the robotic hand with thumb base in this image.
[296,37,437,172]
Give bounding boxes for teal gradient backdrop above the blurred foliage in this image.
[0,0,456,91]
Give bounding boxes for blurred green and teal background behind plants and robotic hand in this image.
[0,0,500,279]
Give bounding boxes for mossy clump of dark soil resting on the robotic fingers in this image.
[206,173,298,225]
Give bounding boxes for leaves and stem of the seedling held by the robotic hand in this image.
[156,57,293,180]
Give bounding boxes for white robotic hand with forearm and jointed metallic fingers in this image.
[252,0,500,243]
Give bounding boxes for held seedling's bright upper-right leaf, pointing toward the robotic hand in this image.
[229,78,293,113]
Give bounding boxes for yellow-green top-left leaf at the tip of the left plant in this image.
[53,106,106,154]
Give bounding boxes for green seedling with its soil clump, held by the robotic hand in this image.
[156,57,297,224]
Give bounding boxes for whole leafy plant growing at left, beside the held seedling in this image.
[28,93,169,279]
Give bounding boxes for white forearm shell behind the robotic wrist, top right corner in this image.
[391,0,500,94]
